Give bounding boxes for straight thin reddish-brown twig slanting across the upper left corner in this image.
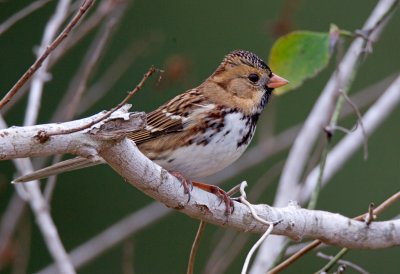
[0,0,93,109]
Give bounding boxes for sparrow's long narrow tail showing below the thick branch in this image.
[13,157,104,183]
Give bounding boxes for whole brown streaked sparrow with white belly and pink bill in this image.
[14,50,289,215]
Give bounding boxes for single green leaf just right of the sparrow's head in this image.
[268,31,331,95]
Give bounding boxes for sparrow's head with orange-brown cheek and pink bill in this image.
[209,50,288,114]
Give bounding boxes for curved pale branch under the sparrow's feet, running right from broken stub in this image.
[100,139,400,248]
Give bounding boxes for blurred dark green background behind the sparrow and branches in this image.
[0,0,400,273]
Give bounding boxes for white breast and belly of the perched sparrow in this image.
[156,112,255,180]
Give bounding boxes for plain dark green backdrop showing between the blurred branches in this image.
[0,0,400,273]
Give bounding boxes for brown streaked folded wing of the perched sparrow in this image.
[128,89,210,144]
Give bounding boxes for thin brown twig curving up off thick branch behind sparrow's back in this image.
[44,66,157,136]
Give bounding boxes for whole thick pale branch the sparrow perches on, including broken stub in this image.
[0,107,400,253]
